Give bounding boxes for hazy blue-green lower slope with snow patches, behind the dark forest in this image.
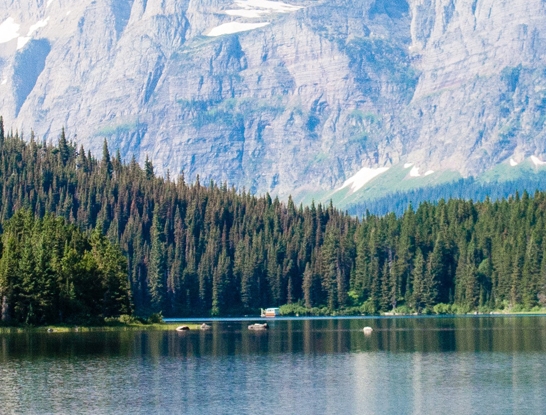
[300,156,546,215]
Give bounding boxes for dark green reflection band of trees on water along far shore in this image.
[0,317,546,361]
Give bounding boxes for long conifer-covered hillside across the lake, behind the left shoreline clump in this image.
[0,117,546,316]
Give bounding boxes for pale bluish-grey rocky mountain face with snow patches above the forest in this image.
[0,0,546,200]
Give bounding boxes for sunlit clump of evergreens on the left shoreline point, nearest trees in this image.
[0,210,130,324]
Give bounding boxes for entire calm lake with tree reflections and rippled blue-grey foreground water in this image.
[0,316,546,415]
